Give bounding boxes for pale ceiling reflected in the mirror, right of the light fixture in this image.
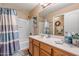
[40,3,72,17]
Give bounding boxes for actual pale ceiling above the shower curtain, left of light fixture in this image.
[0,3,38,12]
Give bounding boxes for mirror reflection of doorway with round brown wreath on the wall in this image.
[53,15,64,36]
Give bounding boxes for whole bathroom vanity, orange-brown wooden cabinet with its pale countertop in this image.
[29,36,79,56]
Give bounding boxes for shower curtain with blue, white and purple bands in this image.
[0,8,20,56]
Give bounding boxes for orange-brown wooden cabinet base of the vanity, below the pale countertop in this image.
[29,38,75,56]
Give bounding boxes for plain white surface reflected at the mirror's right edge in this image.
[64,9,79,33]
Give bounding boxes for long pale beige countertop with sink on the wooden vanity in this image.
[30,35,79,56]
